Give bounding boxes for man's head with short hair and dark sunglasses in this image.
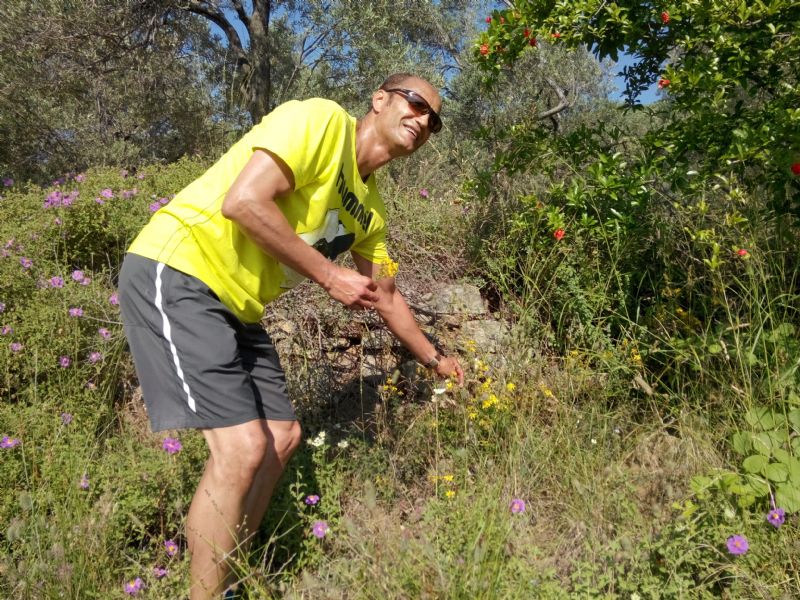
[372,73,442,156]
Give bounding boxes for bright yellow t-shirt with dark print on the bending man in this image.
[128,98,388,323]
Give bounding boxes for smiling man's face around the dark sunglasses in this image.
[377,77,442,155]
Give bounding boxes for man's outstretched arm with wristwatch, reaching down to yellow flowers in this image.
[351,252,464,384]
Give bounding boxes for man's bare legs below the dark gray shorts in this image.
[186,420,300,600]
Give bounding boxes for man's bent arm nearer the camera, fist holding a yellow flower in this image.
[222,150,379,308]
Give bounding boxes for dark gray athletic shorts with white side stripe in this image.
[119,254,296,431]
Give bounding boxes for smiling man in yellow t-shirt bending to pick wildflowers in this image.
[120,73,463,599]
